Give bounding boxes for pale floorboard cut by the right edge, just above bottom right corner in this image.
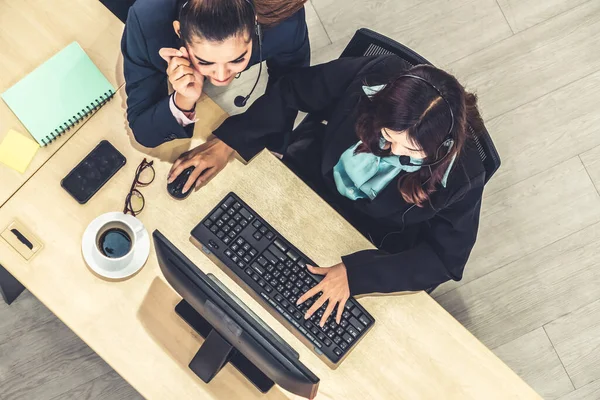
[545,300,600,388]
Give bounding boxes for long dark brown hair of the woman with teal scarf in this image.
[356,65,483,207]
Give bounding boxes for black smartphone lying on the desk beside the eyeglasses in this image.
[60,140,127,204]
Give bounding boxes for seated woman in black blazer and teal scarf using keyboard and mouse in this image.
[171,56,485,323]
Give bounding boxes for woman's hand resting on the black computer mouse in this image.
[167,138,234,193]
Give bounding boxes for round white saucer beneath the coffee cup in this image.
[81,212,150,279]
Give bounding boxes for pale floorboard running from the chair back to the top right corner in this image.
[450,1,600,121]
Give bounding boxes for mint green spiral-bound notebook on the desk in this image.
[2,42,115,146]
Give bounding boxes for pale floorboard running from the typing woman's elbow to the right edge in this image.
[434,157,600,297]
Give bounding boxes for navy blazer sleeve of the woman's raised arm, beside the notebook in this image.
[121,7,194,147]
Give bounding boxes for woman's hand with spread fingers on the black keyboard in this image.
[296,263,350,326]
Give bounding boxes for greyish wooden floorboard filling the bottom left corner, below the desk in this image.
[0,318,111,400]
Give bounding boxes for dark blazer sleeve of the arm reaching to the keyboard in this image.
[342,186,483,295]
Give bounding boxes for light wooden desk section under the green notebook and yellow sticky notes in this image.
[0,0,124,205]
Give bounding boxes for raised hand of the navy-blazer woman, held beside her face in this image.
[158,47,204,110]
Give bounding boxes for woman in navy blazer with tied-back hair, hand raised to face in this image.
[121,0,310,147]
